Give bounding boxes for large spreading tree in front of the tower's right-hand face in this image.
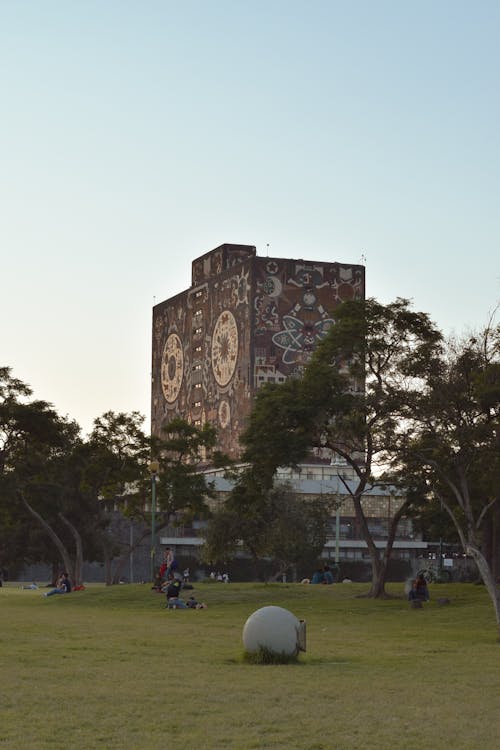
[242,299,441,597]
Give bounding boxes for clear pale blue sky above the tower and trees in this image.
[0,0,500,432]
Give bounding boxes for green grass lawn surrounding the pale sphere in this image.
[0,583,500,750]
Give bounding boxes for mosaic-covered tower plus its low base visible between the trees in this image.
[151,244,426,575]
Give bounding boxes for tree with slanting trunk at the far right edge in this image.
[402,322,500,638]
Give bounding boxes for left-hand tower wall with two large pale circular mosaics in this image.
[151,247,252,456]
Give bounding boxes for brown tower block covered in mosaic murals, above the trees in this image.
[151,244,365,458]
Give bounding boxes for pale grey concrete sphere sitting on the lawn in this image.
[243,606,300,655]
